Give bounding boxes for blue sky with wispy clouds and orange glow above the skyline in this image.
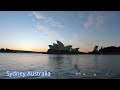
[0,11,120,52]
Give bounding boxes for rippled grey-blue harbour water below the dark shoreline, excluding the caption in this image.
[0,53,120,79]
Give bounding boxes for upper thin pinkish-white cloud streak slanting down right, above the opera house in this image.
[32,11,64,28]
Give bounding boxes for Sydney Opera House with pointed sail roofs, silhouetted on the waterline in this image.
[47,40,79,53]
